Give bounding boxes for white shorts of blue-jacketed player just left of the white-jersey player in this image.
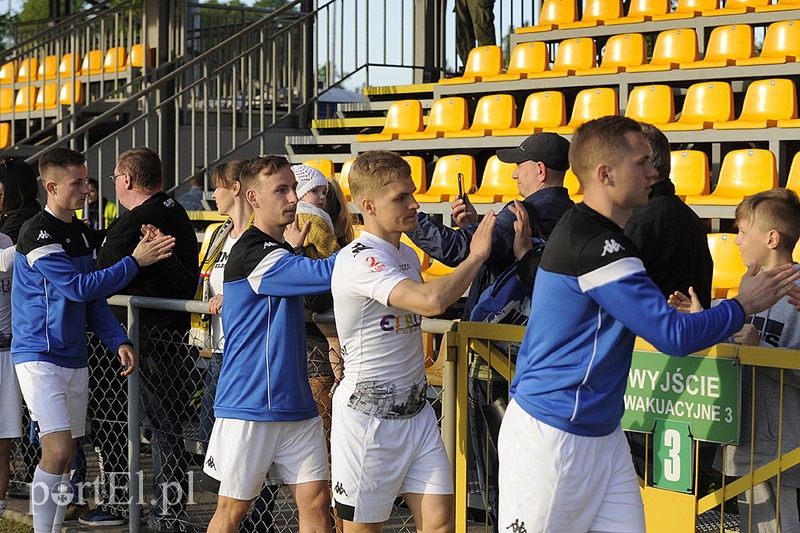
[203,416,330,500]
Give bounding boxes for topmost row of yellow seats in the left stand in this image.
[0,44,152,85]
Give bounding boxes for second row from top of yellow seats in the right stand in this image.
[439,20,800,85]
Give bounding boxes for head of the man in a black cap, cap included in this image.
[497,133,569,198]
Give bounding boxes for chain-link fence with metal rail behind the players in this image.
[10,296,456,533]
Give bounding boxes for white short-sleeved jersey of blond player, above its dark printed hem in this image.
[331,231,425,394]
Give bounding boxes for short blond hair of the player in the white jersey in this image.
[347,150,411,201]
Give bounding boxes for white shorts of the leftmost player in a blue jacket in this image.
[16,361,89,439]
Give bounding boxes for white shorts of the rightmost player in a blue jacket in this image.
[498,400,645,533]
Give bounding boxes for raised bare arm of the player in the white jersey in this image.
[389,211,496,316]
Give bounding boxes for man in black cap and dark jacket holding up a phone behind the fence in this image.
[408,133,575,532]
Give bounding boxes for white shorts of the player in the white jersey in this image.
[331,393,453,523]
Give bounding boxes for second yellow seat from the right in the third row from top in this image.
[654,81,733,131]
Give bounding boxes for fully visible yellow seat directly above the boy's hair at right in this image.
[686,148,778,205]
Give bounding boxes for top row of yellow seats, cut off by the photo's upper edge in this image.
[516,0,800,33]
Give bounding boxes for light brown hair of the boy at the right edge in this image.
[736,188,800,253]
